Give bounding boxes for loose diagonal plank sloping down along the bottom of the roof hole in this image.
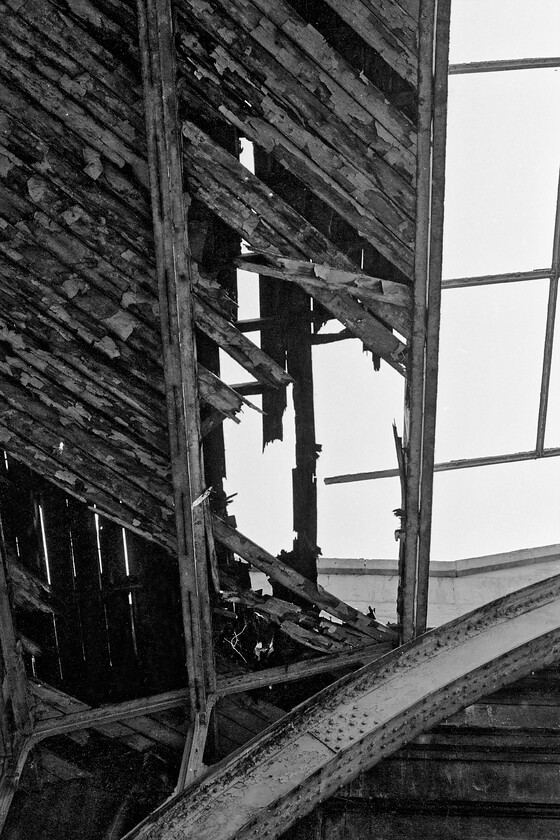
[212,516,394,641]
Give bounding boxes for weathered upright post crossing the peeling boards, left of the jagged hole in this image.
[138,0,215,721]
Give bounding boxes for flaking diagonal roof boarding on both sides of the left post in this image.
[0,0,416,547]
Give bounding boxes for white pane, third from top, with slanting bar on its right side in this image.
[436,280,548,462]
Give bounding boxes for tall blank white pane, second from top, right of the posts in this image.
[444,69,560,278]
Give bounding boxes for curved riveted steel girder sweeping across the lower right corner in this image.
[127,575,560,840]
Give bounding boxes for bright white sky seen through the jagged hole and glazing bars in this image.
[224,0,560,560]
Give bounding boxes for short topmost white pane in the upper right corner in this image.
[450,0,560,63]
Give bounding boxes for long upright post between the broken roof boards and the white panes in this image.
[399,0,449,642]
